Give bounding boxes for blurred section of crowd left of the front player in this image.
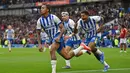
[0,16,37,44]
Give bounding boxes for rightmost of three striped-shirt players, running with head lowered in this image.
[78,11,110,71]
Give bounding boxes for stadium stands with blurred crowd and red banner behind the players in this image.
[0,0,130,47]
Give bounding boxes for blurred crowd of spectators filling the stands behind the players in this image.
[0,0,130,46]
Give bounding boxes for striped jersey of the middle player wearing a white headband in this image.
[64,19,80,41]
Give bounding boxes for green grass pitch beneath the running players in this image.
[0,48,130,73]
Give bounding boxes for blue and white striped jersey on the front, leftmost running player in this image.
[36,14,61,39]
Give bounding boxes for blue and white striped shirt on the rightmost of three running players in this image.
[78,17,97,38]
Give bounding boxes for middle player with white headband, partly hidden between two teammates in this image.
[61,12,90,69]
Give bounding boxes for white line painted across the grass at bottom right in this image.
[57,68,130,73]
